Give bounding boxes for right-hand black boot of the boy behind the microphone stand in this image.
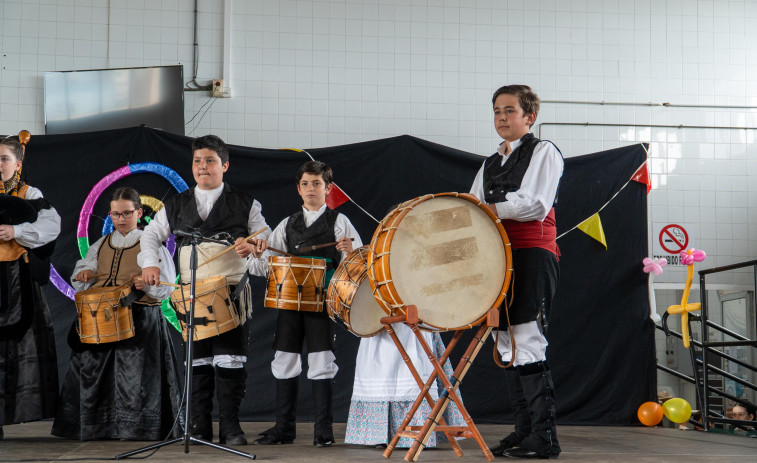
[216,367,247,445]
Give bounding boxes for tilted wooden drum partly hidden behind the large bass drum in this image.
[326,246,386,338]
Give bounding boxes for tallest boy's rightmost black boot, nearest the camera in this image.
[504,362,561,459]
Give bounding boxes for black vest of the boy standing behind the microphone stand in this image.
[165,183,254,245]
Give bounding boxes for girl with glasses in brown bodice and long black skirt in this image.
[52,187,180,440]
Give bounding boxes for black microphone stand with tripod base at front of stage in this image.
[115,230,255,460]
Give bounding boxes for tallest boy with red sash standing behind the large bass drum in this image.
[471,85,563,458]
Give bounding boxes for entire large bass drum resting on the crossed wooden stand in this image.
[368,193,512,330]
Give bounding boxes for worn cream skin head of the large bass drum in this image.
[389,195,508,330]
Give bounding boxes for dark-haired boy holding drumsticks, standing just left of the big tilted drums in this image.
[249,161,362,447]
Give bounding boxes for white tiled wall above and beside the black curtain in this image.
[0,0,757,285]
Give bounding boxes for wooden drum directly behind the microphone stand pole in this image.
[171,275,239,341]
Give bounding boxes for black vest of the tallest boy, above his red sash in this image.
[484,132,562,205]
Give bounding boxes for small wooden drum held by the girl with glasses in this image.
[74,285,134,344]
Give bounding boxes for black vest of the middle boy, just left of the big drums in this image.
[286,208,342,270]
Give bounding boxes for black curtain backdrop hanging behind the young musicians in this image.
[23,127,656,424]
